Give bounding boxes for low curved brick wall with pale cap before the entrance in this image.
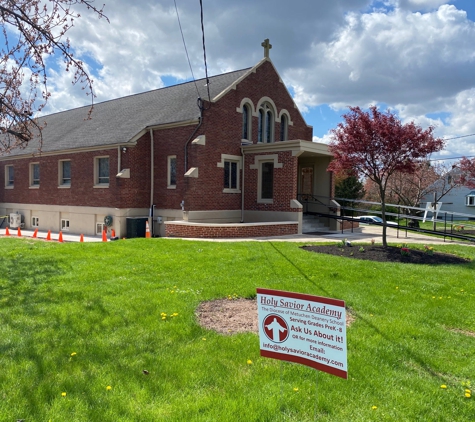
[165,222,298,239]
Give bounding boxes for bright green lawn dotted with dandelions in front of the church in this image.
[0,238,475,422]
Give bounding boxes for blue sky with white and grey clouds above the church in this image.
[40,0,475,158]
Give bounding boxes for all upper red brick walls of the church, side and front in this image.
[0,62,312,216]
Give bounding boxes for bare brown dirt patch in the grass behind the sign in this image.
[196,299,355,335]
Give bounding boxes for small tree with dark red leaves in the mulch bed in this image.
[328,106,444,246]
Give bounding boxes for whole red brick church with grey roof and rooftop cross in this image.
[0,42,332,237]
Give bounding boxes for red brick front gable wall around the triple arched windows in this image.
[178,62,312,211]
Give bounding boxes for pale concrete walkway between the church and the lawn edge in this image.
[0,225,475,246]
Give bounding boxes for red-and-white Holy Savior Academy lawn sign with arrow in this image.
[257,288,348,379]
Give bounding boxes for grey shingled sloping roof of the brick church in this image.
[5,69,249,159]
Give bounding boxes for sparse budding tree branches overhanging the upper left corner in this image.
[0,0,107,155]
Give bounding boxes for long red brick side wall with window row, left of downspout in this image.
[0,146,150,208]
